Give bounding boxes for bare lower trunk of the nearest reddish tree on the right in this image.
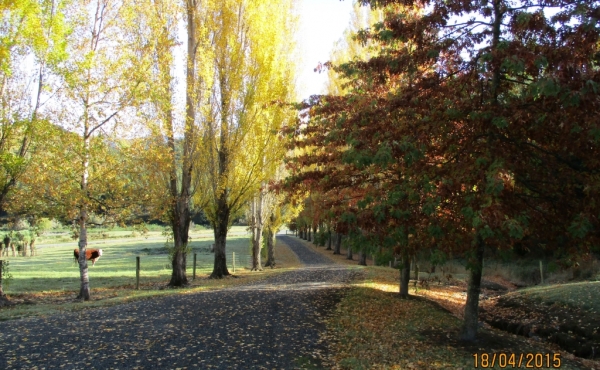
[460,235,485,341]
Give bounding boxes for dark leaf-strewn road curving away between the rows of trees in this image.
[0,235,353,369]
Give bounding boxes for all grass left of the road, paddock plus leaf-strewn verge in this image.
[0,227,300,320]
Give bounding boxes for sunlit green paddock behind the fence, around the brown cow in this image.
[2,223,250,294]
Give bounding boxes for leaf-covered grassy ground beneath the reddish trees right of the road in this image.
[303,238,600,369]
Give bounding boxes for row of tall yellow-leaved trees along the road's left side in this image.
[0,0,295,300]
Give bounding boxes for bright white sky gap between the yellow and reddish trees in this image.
[296,0,353,99]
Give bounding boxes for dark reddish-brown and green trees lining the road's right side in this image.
[285,0,600,340]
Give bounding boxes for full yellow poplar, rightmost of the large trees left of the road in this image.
[197,0,294,278]
